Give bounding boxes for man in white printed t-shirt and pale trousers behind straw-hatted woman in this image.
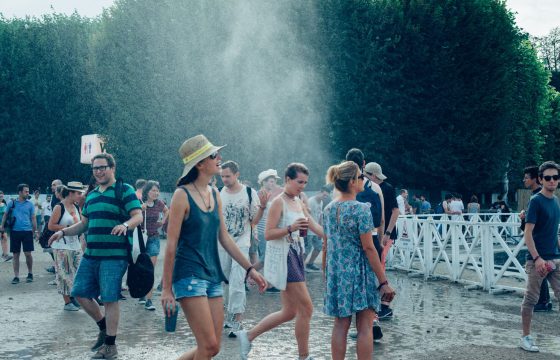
[220,161,268,337]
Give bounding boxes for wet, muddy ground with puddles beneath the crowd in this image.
[0,242,560,360]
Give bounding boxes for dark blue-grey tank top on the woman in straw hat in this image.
[173,187,226,283]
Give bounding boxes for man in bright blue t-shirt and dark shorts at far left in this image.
[0,184,38,285]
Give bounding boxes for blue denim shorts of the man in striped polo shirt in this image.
[71,257,128,302]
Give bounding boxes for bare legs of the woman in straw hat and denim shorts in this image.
[178,296,224,360]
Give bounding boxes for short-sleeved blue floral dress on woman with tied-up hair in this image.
[323,201,380,317]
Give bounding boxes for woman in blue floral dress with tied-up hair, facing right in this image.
[323,161,395,360]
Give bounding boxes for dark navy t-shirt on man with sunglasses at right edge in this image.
[525,193,560,260]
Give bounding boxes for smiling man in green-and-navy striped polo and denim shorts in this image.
[49,154,143,359]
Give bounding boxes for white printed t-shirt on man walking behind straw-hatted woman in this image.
[220,185,261,247]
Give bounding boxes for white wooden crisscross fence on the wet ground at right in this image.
[387,213,527,292]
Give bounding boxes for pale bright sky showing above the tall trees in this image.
[0,0,560,36]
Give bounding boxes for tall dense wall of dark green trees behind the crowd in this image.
[0,0,560,197]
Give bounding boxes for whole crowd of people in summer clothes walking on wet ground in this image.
[0,135,560,360]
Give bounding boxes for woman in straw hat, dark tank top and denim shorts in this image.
[161,135,267,359]
